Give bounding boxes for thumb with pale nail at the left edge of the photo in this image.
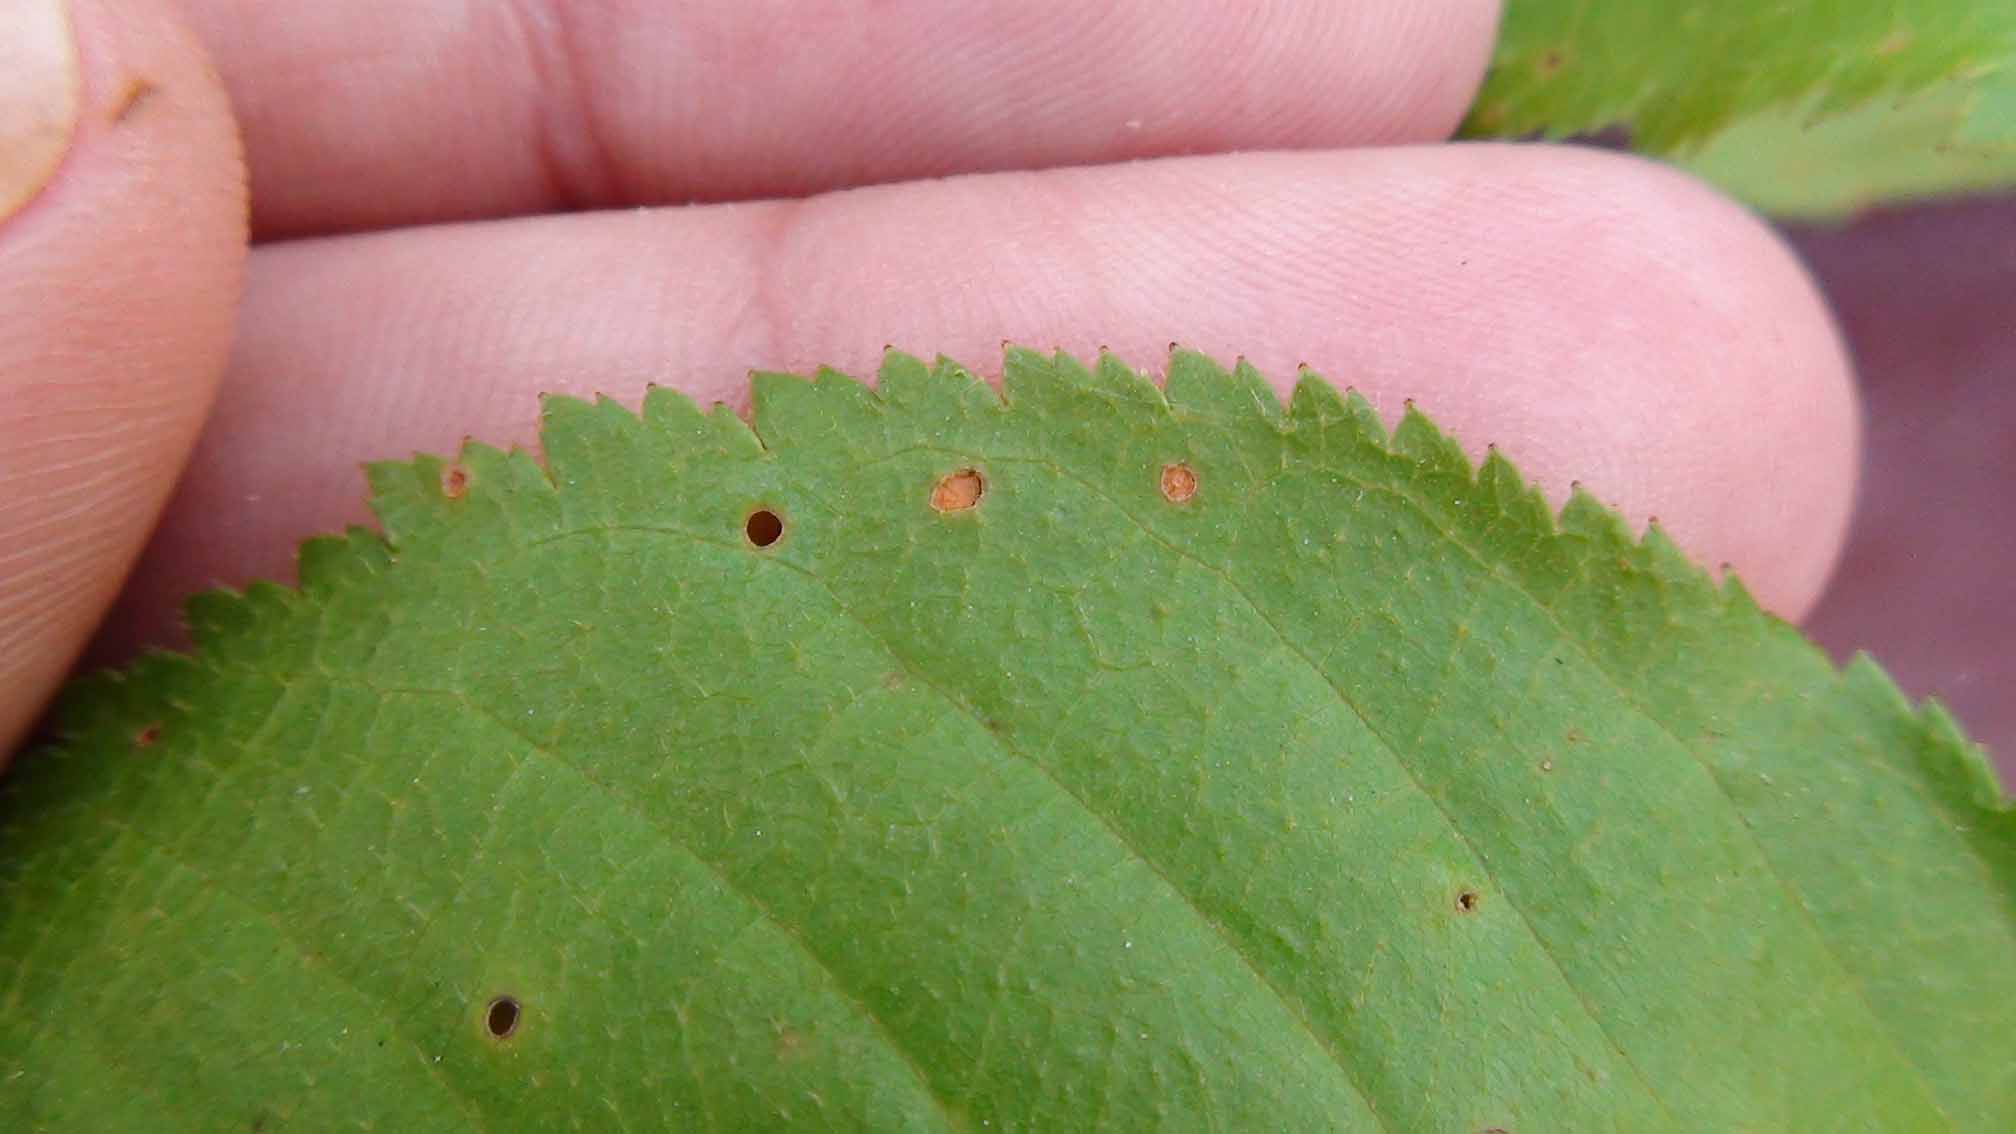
[0,0,246,765]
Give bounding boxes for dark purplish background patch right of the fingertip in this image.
[1786,194,2016,785]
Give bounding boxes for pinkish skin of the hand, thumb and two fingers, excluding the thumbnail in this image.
[0,0,1857,753]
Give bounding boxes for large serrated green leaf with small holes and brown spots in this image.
[0,353,2016,1132]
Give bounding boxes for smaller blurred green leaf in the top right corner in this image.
[1466,0,2016,216]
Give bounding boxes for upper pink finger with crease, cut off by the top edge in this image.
[190,0,1498,236]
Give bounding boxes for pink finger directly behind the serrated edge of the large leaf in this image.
[98,145,1857,657]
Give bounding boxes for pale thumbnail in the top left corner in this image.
[0,0,81,220]
